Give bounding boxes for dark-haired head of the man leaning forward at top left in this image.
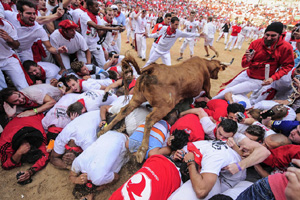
[17,0,36,26]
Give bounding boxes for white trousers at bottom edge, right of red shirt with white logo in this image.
[168,179,223,200]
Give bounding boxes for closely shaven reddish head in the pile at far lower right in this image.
[263,133,291,149]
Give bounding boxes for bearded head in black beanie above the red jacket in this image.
[264,22,283,47]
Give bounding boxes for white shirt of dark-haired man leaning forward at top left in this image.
[5,11,49,52]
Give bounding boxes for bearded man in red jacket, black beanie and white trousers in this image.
[213,22,294,99]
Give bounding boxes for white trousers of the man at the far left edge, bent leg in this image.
[0,57,28,90]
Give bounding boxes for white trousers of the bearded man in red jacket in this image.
[213,71,263,99]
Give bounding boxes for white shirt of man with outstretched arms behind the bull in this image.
[149,26,200,54]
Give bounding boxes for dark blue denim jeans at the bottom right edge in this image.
[236,177,275,200]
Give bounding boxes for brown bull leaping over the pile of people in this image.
[98,56,231,163]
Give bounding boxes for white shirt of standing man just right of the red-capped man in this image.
[80,13,103,51]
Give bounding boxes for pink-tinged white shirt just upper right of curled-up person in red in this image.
[42,93,80,130]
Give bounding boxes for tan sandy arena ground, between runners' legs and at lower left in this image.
[0,32,249,200]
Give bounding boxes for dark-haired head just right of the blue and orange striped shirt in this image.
[168,129,189,151]
